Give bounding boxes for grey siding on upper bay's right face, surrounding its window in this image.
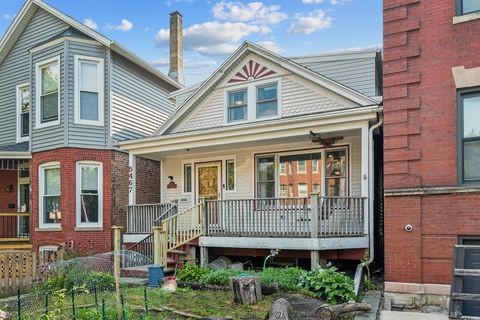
[66,42,109,149]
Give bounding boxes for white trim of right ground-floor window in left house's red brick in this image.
[75,161,103,229]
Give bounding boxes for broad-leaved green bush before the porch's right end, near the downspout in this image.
[298,267,356,304]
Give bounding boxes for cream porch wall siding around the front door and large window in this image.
[161,136,362,210]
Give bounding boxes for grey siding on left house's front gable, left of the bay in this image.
[0,9,67,149]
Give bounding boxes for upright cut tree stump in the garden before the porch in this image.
[230,276,262,304]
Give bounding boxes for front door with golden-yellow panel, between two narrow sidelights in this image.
[197,162,222,202]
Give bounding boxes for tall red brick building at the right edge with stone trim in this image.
[383,0,480,312]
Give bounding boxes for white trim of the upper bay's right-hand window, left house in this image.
[74,55,105,126]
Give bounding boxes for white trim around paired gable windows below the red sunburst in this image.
[223,77,282,126]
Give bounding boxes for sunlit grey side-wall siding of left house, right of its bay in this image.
[112,56,175,141]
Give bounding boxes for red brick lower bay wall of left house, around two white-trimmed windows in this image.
[31,148,114,253]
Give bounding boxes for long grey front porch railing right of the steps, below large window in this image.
[205,196,368,238]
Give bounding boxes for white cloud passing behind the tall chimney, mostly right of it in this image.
[155,21,271,56]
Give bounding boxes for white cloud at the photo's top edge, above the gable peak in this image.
[212,1,288,25]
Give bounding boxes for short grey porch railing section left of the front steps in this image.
[127,202,177,234]
